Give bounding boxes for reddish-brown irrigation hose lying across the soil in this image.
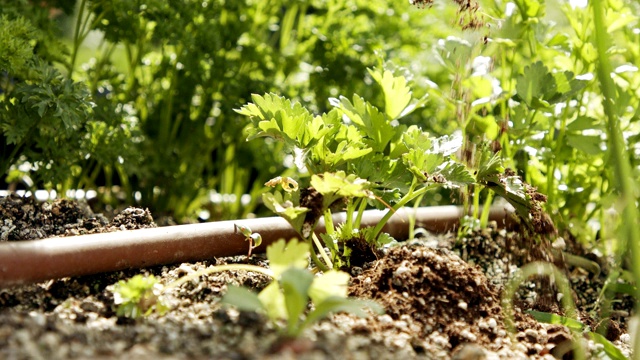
[0,206,510,287]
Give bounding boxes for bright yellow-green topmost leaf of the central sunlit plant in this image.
[367,69,412,119]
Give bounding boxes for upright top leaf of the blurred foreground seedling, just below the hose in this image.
[267,239,309,279]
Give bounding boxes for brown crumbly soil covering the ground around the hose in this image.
[0,196,631,360]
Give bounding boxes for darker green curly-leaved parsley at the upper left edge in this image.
[0,1,131,190]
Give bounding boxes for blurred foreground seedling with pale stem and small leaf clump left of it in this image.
[111,239,382,338]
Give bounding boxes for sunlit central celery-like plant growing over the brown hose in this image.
[238,69,538,268]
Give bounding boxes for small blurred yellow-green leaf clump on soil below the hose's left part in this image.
[113,275,169,319]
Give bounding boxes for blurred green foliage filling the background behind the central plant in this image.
[0,0,640,249]
